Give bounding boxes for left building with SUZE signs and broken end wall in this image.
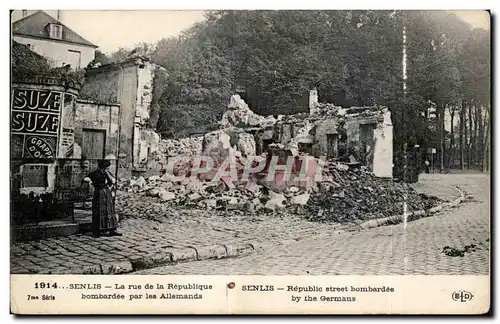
[11,53,170,228]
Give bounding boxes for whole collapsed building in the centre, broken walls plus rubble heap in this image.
[119,91,408,218]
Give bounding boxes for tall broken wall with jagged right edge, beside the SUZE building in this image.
[80,57,169,177]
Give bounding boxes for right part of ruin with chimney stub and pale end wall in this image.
[276,90,393,178]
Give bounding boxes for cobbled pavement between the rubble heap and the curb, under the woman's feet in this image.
[11,209,348,274]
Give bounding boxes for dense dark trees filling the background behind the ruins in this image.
[103,10,490,171]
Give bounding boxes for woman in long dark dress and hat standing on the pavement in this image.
[89,160,122,237]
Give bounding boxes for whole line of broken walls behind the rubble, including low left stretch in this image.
[132,95,392,177]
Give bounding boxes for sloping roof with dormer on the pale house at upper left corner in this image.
[12,10,98,47]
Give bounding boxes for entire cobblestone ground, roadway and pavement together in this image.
[11,175,489,274]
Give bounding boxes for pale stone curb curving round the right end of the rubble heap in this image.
[359,187,465,229]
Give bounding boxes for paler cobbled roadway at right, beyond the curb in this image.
[136,174,490,275]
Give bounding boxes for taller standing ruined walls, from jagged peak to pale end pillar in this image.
[196,90,393,178]
